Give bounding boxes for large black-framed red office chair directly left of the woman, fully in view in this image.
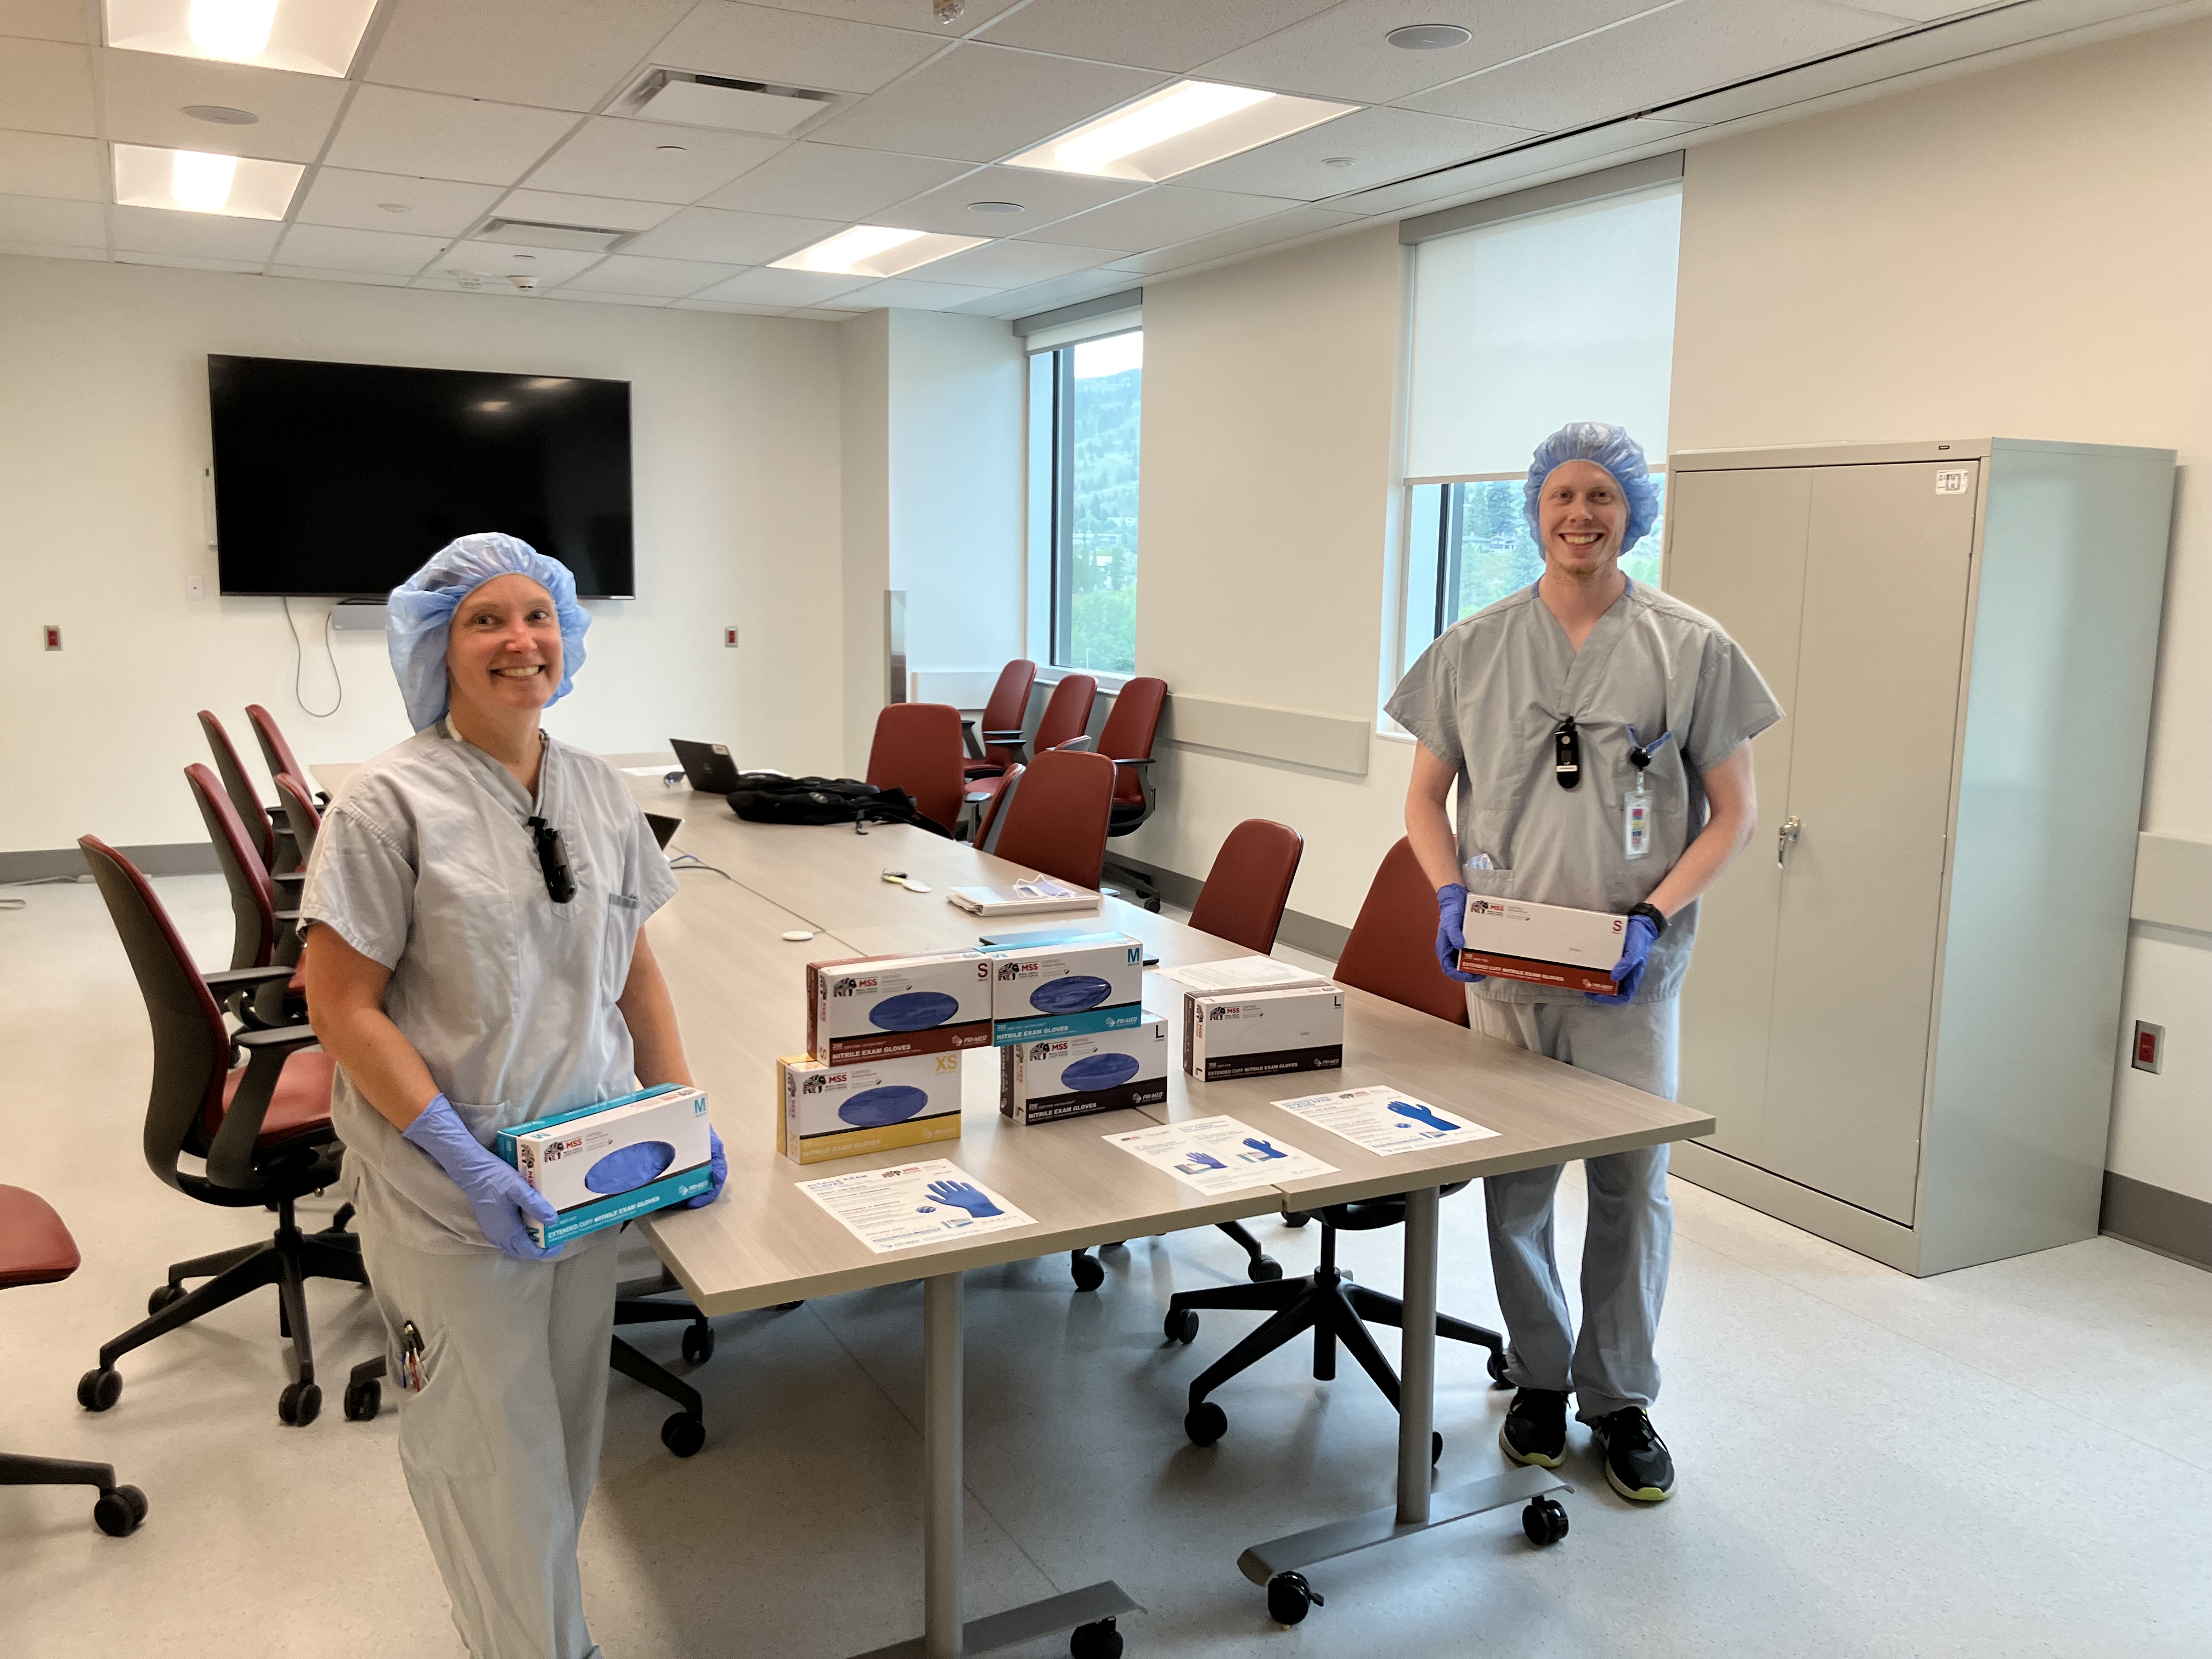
[77,836,376,1427]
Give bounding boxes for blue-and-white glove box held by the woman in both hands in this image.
[498,1084,714,1250]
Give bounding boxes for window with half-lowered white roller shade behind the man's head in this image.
[1396,184,1681,673]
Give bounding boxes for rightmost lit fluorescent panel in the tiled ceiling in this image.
[1007,80,1358,184]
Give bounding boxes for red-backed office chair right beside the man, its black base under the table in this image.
[1166,838,1509,1460]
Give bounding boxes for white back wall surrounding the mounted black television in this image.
[0,259,840,851]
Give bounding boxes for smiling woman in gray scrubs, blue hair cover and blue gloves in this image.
[301,535,725,1659]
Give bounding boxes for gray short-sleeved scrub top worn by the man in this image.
[1387,582,1783,1002]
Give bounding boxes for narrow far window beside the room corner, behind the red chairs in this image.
[1029,330,1144,675]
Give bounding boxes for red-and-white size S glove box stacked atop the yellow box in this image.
[808,951,991,1064]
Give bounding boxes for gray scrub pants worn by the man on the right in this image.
[1466,993,1681,1423]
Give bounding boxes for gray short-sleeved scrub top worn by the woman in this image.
[301,723,677,1254]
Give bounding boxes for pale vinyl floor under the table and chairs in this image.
[0,876,2212,1659]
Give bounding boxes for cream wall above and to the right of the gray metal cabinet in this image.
[1672,22,2212,1199]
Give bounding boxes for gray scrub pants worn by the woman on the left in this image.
[360,1228,622,1659]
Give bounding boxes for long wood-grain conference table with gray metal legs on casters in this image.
[317,754,1714,1659]
